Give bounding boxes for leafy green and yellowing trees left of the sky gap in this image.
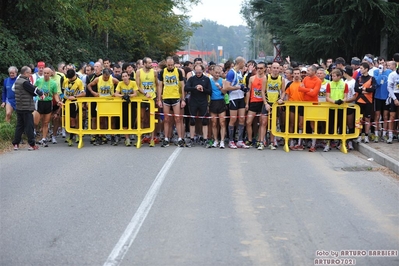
[0,0,199,80]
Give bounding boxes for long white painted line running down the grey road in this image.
[104,148,182,266]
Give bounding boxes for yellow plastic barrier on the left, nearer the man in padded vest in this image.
[62,97,158,149]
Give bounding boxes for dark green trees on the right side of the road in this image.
[243,0,399,63]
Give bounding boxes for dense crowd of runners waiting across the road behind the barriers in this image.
[1,53,399,152]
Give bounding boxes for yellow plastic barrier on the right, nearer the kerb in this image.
[271,102,362,153]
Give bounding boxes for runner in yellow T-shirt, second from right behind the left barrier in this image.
[114,71,138,147]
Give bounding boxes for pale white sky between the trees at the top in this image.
[187,0,246,27]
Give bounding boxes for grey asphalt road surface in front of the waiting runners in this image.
[0,140,399,266]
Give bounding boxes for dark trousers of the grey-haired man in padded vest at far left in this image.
[12,111,36,146]
